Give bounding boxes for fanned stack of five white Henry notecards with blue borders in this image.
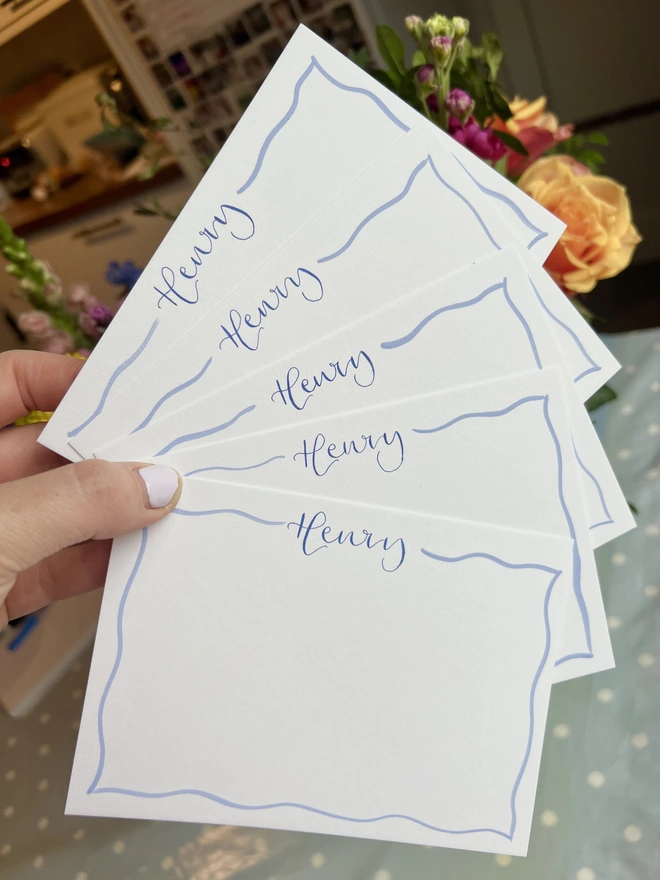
[37,28,633,855]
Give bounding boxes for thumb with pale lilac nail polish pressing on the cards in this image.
[0,459,182,604]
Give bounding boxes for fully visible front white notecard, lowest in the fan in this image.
[67,480,571,855]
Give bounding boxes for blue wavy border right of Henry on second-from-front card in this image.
[413,394,594,666]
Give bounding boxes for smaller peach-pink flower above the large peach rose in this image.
[492,95,573,177]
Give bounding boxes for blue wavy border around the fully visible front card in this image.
[87,520,562,840]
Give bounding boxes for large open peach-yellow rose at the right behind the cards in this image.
[518,156,642,296]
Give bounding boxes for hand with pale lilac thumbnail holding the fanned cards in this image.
[0,351,181,629]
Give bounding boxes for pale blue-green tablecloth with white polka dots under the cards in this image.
[0,330,660,880]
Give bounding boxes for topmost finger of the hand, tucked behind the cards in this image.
[0,351,84,426]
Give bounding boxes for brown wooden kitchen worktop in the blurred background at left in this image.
[2,162,183,237]
